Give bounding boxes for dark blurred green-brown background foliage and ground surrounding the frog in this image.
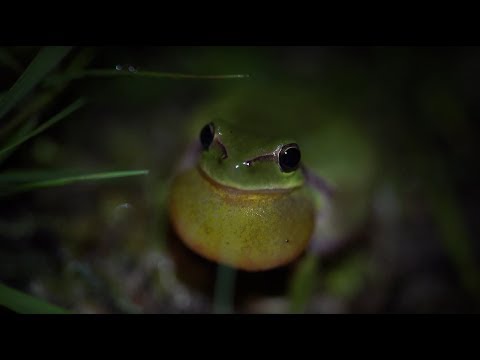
[0,47,480,313]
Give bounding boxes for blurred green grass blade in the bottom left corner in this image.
[0,283,69,314]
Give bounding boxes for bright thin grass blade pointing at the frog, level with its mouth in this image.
[2,170,149,195]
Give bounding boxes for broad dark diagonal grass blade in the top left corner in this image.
[0,46,71,119]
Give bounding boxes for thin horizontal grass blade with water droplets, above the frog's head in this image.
[47,69,249,85]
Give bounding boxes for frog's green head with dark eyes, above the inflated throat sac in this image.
[199,120,304,191]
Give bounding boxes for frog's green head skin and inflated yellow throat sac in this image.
[169,120,326,271]
